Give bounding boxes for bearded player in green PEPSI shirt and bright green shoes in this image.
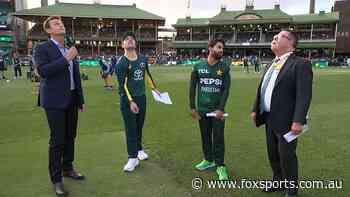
[189,39,231,180]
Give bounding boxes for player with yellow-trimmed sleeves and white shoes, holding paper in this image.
[116,32,159,172]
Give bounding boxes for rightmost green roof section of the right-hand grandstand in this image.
[293,12,339,24]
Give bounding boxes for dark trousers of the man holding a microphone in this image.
[45,91,78,183]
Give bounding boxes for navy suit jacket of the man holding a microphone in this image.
[34,40,84,109]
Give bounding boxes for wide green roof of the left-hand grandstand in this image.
[13,3,165,22]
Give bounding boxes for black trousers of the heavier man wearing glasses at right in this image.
[265,115,298,194]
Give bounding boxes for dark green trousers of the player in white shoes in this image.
[120,95,146,158]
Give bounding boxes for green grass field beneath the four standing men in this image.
[0,67,350,197]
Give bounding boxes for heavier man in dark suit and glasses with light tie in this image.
[251,31,313,197]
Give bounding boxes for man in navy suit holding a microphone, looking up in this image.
[34,16,84,196]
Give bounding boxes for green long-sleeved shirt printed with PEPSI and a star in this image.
[190,61,231,113]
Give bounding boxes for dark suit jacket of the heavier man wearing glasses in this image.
[252,54,313,133]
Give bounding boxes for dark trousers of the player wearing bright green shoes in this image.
[199,113,225,166]
